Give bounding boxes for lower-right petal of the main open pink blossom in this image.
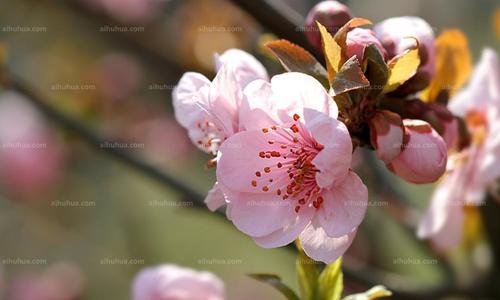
[315,171,368,237]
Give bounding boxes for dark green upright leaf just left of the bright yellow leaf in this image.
[363,44,389,97]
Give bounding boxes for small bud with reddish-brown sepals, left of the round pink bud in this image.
[369,110,404,163]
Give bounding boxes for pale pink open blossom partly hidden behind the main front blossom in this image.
[173,49,268,210]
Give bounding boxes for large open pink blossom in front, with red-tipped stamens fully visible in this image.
[217,73,368,263]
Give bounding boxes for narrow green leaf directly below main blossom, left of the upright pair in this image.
[295,241,319,300]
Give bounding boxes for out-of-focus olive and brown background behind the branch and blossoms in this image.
[0,0,500,300]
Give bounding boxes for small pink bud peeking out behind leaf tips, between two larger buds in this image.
[347,28,387,62]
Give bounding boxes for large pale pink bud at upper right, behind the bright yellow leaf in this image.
[373,17,435,94]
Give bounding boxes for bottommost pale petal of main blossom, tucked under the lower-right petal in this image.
[299,224,356,264]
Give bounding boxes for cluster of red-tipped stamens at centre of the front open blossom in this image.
[251,114,323,213]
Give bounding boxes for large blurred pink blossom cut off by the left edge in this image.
[0,92,64,197]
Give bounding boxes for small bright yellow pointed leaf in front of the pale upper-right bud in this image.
[383,43,420,93]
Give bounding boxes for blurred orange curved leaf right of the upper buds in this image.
[421,29,472,102]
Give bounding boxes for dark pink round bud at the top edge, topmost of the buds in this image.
[306,1,352,49]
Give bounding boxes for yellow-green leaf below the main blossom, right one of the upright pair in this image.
[318,258,344,300]
